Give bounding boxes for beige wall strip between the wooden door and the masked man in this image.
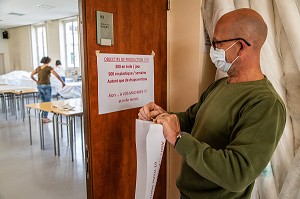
[167,0,215,199]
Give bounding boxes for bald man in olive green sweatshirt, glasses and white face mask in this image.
[138,9,286,199]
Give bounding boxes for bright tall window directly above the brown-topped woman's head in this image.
[35,25,47,63]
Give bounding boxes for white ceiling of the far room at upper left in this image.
[0,0,78,30]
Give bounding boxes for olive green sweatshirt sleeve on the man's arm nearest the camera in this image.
[175,99,286,192]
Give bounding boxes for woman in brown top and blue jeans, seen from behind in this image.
[31,57,65,123]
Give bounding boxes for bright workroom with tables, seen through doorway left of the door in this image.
[0,0,87,199]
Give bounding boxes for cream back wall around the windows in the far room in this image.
[0,17,72,73]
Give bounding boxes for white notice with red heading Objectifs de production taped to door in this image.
[97,53,154,114]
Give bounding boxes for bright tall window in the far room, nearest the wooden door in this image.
[64,19,80,68]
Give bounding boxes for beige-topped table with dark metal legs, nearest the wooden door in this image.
[26,98,83,161]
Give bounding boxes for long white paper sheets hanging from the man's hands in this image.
[135,120,166,199]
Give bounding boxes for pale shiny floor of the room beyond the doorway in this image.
[0,99,86,199]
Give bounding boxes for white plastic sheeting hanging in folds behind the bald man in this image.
[202,0,300,199]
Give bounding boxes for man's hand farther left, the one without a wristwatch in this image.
[138,102,167,121]
